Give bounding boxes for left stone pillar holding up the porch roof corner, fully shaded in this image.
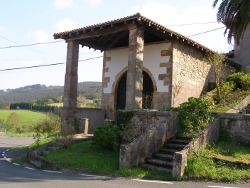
[61,40,79,134]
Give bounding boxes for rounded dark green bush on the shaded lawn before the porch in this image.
[92,124,121,150]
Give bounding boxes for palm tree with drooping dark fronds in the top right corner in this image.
[213,0,250,45]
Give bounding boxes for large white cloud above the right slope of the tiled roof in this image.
[128,1,229,52]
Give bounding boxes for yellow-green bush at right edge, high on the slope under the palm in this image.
[227,72,250,90]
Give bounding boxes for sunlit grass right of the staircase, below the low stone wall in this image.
[184,141,250,182]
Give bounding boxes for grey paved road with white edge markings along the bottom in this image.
[0,137,250,188]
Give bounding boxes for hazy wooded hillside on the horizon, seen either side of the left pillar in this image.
[0,82,102,104]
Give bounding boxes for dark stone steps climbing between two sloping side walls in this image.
[141,137,191,173]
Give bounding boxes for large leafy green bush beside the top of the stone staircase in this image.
[168,97,213,135]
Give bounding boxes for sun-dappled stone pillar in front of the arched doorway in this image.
[126,26,144,110]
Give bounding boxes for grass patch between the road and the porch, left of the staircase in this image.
[45,140,171,180]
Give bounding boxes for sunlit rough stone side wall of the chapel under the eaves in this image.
[172,40,211,106]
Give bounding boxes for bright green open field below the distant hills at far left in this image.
[0,110,47,125]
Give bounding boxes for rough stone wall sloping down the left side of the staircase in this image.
[119,111,178,168]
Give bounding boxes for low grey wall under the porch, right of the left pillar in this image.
[76,108,105,133]
